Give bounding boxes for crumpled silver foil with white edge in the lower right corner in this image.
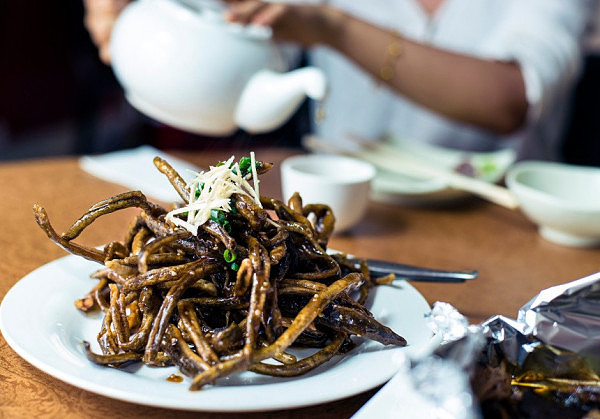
[355,272,600,419]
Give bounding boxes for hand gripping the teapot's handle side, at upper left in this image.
[84,0,131,64]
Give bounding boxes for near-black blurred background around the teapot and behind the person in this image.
[0,0,600,165]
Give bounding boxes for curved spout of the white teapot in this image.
[235,67,327,133]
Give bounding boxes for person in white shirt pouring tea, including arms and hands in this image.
[85,0,594,160]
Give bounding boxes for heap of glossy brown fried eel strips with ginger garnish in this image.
[34,154,406,390]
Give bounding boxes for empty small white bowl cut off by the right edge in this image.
[506,161,600,247]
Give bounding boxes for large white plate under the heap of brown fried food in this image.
[0,256,431,411]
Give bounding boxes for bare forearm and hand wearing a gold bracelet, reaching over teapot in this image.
[227,0,528,134]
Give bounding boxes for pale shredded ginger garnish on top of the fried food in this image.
[166,152,262,235]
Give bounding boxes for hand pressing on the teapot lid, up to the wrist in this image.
[225,0,335,47]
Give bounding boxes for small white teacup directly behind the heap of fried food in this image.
[281,154,376,233]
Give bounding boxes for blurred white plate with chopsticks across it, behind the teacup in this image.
[371,139,516,205]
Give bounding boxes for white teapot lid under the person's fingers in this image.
[170,0,272,39]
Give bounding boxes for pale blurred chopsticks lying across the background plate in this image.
[302,135,519,209]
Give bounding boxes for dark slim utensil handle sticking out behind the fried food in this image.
[367,259,479,282]
